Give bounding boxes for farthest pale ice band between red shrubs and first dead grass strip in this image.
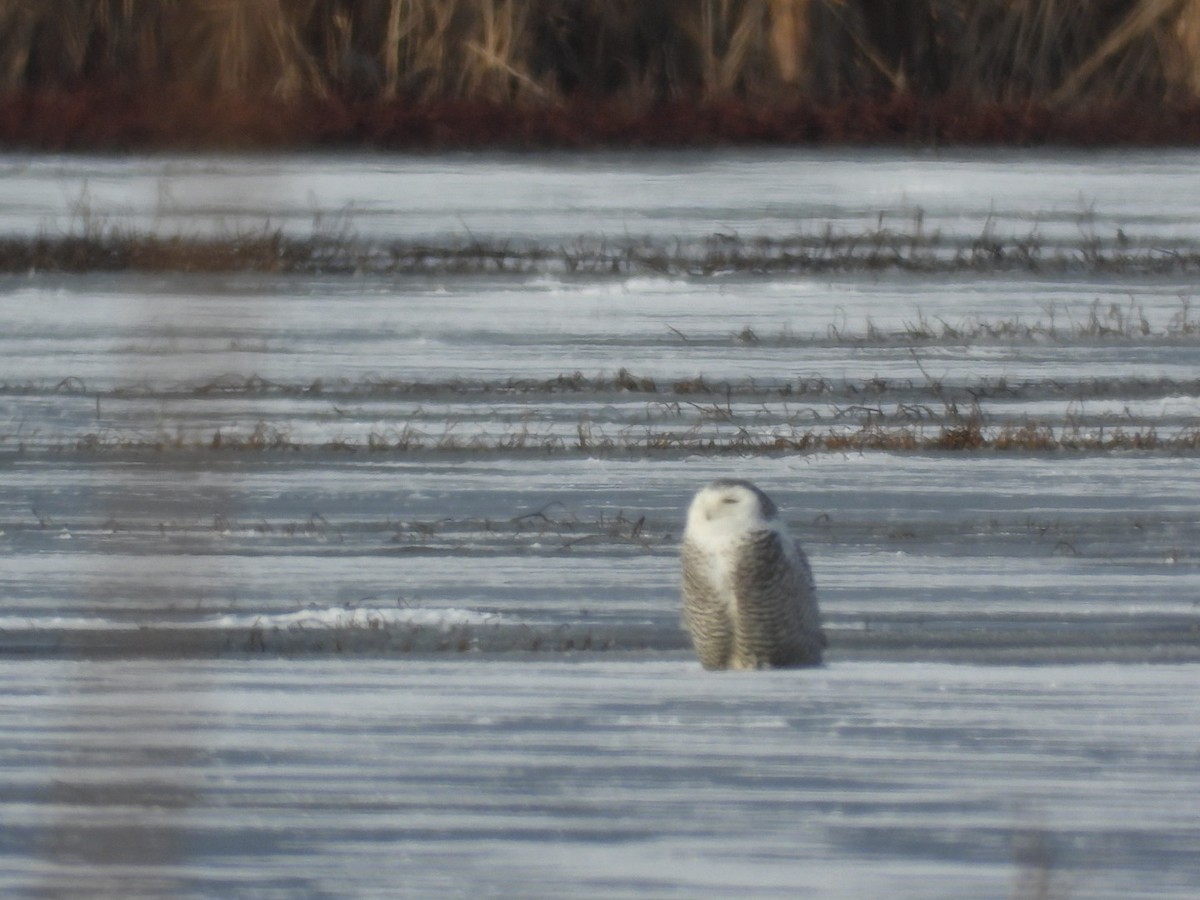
[7,149,1200,242]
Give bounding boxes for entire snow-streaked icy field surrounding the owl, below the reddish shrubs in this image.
[0,152,1200,898]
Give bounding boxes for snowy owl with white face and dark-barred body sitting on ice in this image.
[679,479,826,668]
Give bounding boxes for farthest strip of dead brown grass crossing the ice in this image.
[0,226,1200,277]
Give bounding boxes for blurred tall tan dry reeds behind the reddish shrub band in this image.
[0,0,1200,144]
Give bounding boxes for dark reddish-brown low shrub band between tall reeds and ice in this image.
[7,88,1200,151]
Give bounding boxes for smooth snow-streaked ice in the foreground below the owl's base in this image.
[0,658,1200,899]
